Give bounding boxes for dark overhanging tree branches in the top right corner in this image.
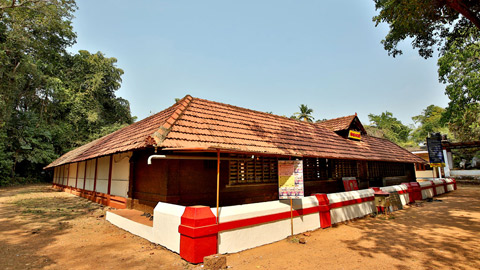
[373,0,480,58]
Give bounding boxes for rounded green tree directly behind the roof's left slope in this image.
[58,51,133,147]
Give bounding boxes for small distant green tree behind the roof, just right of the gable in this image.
[367,111,411,145]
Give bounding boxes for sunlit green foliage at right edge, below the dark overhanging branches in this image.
[438,35,480,141]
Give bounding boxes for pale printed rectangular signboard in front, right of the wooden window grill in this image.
[278,160,304,200]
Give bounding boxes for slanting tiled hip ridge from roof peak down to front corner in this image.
[145,95,193,146]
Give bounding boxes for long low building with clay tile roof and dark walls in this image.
[46,95,425,211]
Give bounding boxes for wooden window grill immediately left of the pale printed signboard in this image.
[229,154,278,185]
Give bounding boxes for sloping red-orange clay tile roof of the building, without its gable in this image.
[46,96,423,168]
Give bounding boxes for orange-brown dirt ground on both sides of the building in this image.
[0,185,480,269]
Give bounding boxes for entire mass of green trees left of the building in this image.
[0,0,133,185]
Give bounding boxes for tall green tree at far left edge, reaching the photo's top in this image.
[0,0,76,183]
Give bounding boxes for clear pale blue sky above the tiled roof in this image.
[71,0,448,124]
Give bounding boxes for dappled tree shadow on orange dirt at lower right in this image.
[344,187,480,269]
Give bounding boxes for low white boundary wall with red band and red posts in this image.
[107,179,457,263]
